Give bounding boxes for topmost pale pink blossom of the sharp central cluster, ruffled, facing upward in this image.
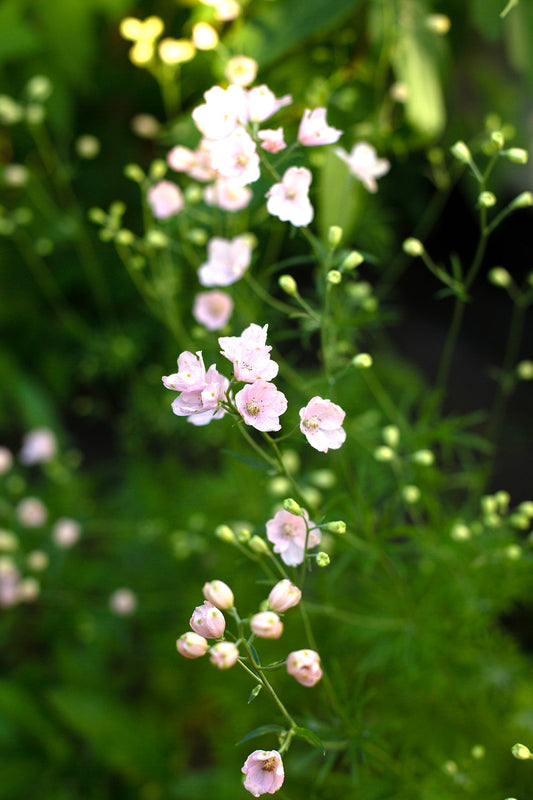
[218,322,282,382]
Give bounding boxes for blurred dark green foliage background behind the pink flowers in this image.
[0,0,533,800]
